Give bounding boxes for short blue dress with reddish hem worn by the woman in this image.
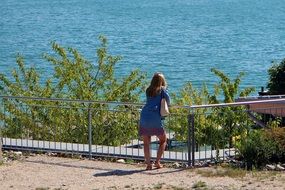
[139,89,170,136]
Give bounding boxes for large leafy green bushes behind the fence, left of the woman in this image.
[0,36,145,145]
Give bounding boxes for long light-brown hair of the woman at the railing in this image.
[146,73,167,97]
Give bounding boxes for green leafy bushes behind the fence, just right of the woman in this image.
[169,69,254,156]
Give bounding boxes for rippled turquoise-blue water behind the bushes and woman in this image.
[0,0,285,94]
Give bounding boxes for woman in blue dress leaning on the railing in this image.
[139,73,170,170]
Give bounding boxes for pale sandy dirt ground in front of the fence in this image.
[0,155,285,190]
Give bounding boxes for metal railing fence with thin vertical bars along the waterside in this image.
[0,96,285,166]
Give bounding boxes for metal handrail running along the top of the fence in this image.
[0,95,285,109]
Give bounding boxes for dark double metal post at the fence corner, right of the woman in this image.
[187,114,195,167]
